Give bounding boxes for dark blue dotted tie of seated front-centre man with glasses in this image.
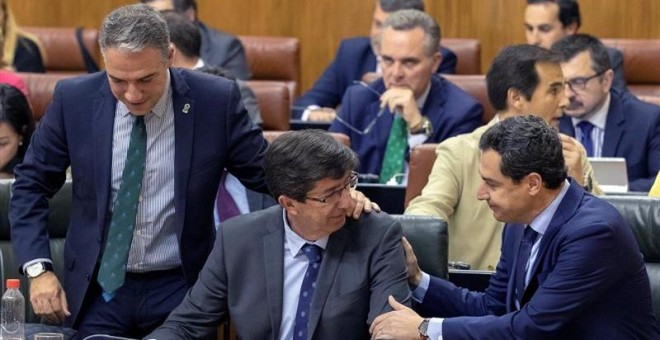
[293,243,323,340]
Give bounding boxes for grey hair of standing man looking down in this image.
[99,4,170,60]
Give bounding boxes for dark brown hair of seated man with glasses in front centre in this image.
[264,129,358,202]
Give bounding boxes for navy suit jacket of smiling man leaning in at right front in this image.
[420,181,658,339]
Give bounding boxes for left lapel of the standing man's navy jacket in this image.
[92,77,117,239]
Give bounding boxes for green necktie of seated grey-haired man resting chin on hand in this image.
[380,115,408,183]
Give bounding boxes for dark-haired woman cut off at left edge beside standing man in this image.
[0,84,34,179]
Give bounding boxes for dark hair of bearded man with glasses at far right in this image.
[552,33,612,73]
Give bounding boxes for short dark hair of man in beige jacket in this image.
[486,44,559,111]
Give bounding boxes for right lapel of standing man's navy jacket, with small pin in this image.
[170,69,196,235]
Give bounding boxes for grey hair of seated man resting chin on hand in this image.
[375,9,440,56]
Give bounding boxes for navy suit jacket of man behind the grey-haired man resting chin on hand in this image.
[292,37,456,119]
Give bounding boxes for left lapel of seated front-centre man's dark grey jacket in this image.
[263,208,284,338]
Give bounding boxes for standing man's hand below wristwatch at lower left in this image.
[30,271,71,324]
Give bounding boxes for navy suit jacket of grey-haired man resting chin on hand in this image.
[330,75,483,175]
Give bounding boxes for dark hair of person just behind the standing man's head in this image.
[161,11,202,58]
